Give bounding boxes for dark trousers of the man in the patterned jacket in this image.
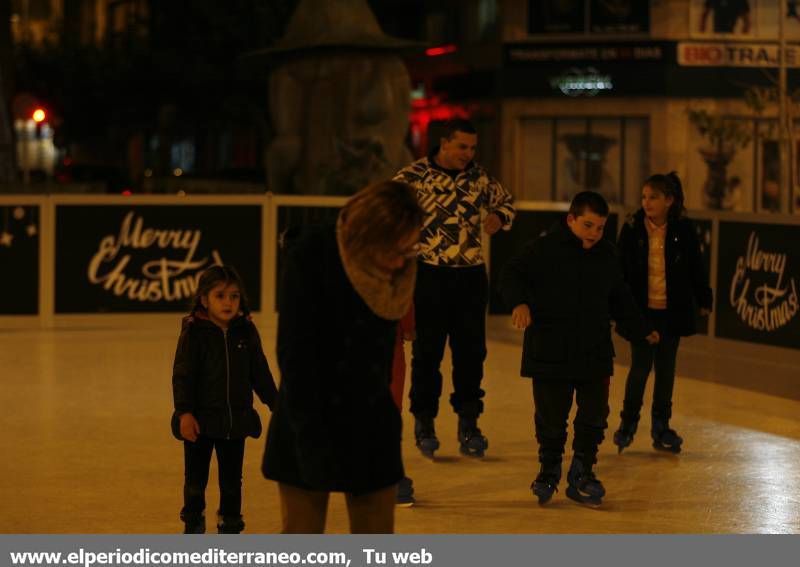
[409,262,489,418]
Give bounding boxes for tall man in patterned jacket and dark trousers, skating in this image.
[395,120,515,458]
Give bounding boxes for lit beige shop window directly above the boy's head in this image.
[517,117,649,206]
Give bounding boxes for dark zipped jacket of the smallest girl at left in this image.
[172,309,277,439]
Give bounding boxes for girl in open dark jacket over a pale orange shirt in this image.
[614,172,712,453]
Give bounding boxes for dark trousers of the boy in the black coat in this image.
[533,378,609,470]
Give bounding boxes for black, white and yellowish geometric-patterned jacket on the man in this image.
[395,154,515,267]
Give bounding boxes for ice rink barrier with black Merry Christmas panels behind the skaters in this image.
[0,193,800,349]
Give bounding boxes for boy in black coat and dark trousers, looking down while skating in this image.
[500,191,658,506]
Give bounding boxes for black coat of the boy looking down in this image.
[500,223,651,382]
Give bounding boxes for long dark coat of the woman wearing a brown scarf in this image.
[262,227,403,493]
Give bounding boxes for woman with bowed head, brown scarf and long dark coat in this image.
[262,181,422,533]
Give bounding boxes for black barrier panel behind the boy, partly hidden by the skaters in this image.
[489,211,618,315]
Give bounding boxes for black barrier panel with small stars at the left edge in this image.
[0,205,41,315]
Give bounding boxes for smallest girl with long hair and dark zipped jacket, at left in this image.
[172,266,277,533]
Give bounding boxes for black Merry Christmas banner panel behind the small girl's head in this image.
[55,205,262,313]
